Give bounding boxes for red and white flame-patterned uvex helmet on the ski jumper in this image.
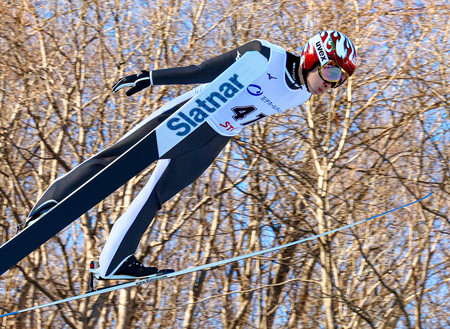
[300,30,357,87]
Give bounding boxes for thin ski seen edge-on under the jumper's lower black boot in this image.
[0,193,433,318]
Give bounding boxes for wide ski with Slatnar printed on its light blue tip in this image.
[0,51,268,275]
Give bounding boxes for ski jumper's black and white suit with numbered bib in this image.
[27,40,311,278]
